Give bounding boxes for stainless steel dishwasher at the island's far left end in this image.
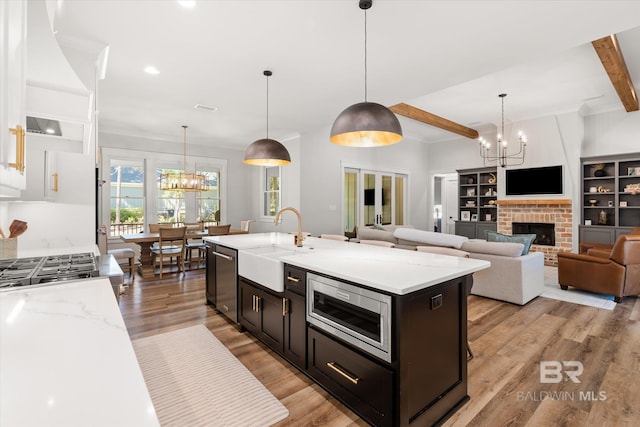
[213,245,238,323]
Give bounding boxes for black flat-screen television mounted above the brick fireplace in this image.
[505,165,564,196]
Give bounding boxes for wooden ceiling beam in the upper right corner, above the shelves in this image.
[591,34,638,112]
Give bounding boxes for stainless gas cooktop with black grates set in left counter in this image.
[0,252,99,291]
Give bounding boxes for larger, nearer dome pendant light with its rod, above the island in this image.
[329,0,402,147]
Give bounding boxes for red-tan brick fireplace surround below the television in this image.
[496,199,573,267]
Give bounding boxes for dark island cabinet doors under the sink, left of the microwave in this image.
[238,266,307,370]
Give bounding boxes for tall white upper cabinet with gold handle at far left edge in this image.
[0,1,27,197]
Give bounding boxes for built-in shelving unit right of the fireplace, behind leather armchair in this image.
[580,153,640,244]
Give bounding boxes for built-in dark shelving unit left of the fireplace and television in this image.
[456,168,498,239]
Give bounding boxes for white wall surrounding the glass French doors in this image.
[300,128,428,236]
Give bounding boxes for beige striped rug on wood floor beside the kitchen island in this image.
[133,325,289,427]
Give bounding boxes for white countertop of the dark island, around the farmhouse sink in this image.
[205,233,491,295]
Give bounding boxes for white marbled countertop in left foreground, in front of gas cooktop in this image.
[0,278,159,427]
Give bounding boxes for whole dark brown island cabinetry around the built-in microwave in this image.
[208,251,473,427]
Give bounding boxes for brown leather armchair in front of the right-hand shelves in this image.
[558,234,640,302]
